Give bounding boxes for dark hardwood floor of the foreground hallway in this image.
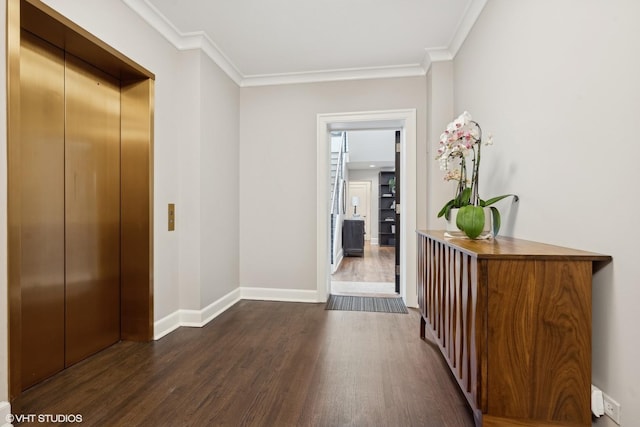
[12,301,473,427]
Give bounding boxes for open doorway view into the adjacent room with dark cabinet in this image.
[331,129,400,296]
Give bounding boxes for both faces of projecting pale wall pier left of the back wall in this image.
[176,50,240,310]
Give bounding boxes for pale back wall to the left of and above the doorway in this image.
[240,77,426,290]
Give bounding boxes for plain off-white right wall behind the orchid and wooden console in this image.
[454,0,640,427]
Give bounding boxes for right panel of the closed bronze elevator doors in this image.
[65,54,120,366]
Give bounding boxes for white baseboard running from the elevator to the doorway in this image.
[153,287,322,340]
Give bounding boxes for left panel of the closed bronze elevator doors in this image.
[17,32,64,389]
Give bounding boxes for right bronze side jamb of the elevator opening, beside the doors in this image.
[120,79,153,341]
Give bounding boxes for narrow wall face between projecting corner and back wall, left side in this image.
[200,53,240,308]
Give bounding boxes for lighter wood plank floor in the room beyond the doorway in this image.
[331,242,396,282]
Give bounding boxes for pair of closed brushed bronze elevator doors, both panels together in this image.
[20,31,120,389]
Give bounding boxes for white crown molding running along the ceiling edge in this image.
[122,0,488,87]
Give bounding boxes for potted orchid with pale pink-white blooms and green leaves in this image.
[436,111,518,239]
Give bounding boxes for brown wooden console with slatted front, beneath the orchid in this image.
[418,231,611,426]
